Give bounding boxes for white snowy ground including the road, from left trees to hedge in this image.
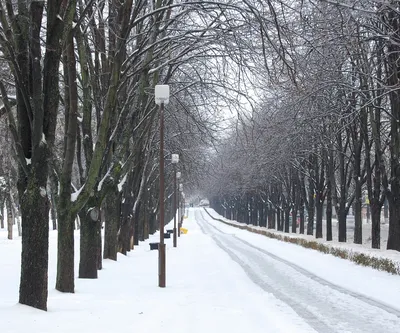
[0,208,400,333]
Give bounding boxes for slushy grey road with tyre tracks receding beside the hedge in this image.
[194,210,400,333]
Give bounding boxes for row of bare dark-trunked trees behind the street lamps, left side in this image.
[0,0,294,310]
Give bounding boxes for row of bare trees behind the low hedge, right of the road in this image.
[208,1,400,251]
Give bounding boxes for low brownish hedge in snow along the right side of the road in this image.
[204,209,400,275]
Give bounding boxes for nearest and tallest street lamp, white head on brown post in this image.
[154,84,169,288]
